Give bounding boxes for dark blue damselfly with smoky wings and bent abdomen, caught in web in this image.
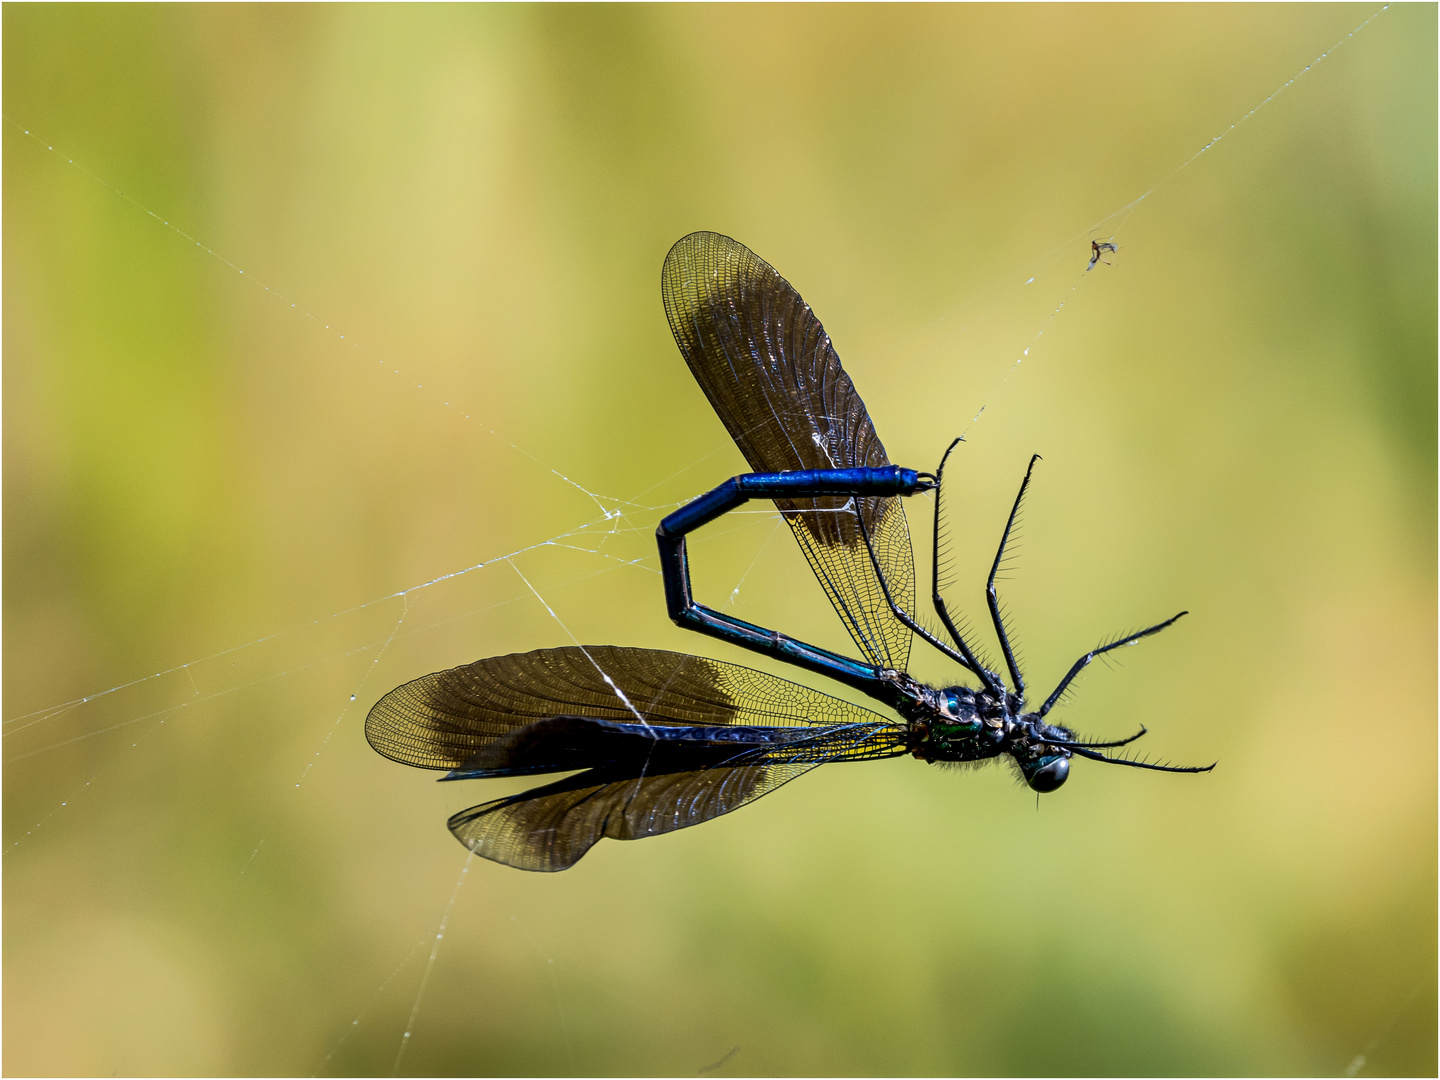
[366,232,1214,871]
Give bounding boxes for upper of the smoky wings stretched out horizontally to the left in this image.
[366,645,887,776]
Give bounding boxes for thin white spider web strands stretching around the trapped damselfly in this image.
[4,9,1416,1073]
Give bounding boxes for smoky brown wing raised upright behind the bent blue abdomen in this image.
[661,232,914,670]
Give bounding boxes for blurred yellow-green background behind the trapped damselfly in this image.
[3,4,1437,1076]
